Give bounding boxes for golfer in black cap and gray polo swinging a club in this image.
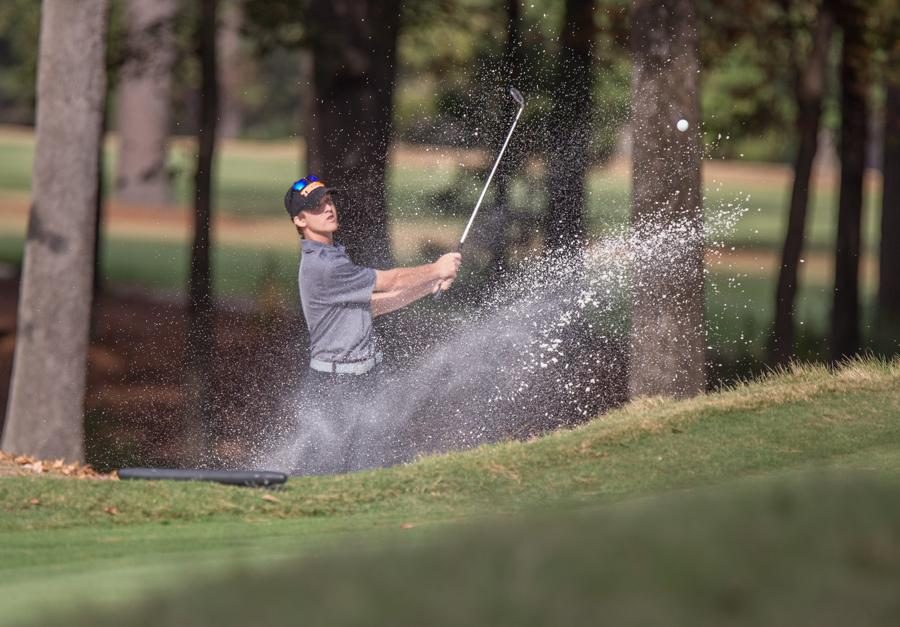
[284,175,461,471]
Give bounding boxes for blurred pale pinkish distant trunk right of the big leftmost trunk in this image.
[115,0,179,205]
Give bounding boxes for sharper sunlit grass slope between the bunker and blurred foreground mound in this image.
[0,361,900,622]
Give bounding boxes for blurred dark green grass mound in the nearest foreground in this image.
[37,475,900,627]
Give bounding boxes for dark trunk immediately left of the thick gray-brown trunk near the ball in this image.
[545,0,596,250]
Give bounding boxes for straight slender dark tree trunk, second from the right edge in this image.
[831,0,869,361]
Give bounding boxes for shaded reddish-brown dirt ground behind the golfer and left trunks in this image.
[0,278,305,472]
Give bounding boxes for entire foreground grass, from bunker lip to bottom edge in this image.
[0,361,900,625]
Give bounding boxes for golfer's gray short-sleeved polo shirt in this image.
[299,240,375,362]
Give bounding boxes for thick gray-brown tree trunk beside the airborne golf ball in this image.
[629,0,706,397]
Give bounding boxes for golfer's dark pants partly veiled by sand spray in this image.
[301,366,381,474]
